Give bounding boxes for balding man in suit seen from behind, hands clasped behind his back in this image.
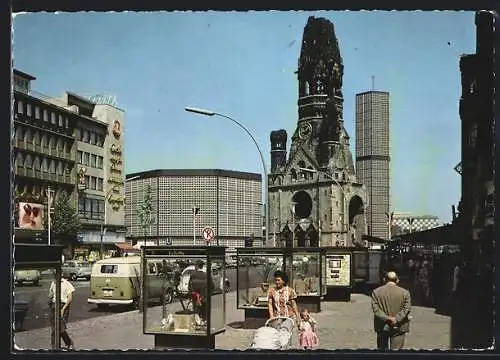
[372,271,411,350]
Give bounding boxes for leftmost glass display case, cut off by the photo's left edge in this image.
[11,244,67,350]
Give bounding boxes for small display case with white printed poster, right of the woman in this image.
[324,247,354,300]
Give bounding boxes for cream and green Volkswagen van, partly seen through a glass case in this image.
[87,256,175,308]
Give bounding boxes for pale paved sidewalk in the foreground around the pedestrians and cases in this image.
[15,292,450,350]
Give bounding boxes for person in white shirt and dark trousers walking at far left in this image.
[49,278,75,350]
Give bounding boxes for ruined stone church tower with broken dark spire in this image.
[269,16,367,247]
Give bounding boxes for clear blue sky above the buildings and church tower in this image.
[13,11,476,223]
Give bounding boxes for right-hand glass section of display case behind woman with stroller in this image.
[285,247,326,312]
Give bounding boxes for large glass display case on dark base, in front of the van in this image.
[141,246,229,348]
